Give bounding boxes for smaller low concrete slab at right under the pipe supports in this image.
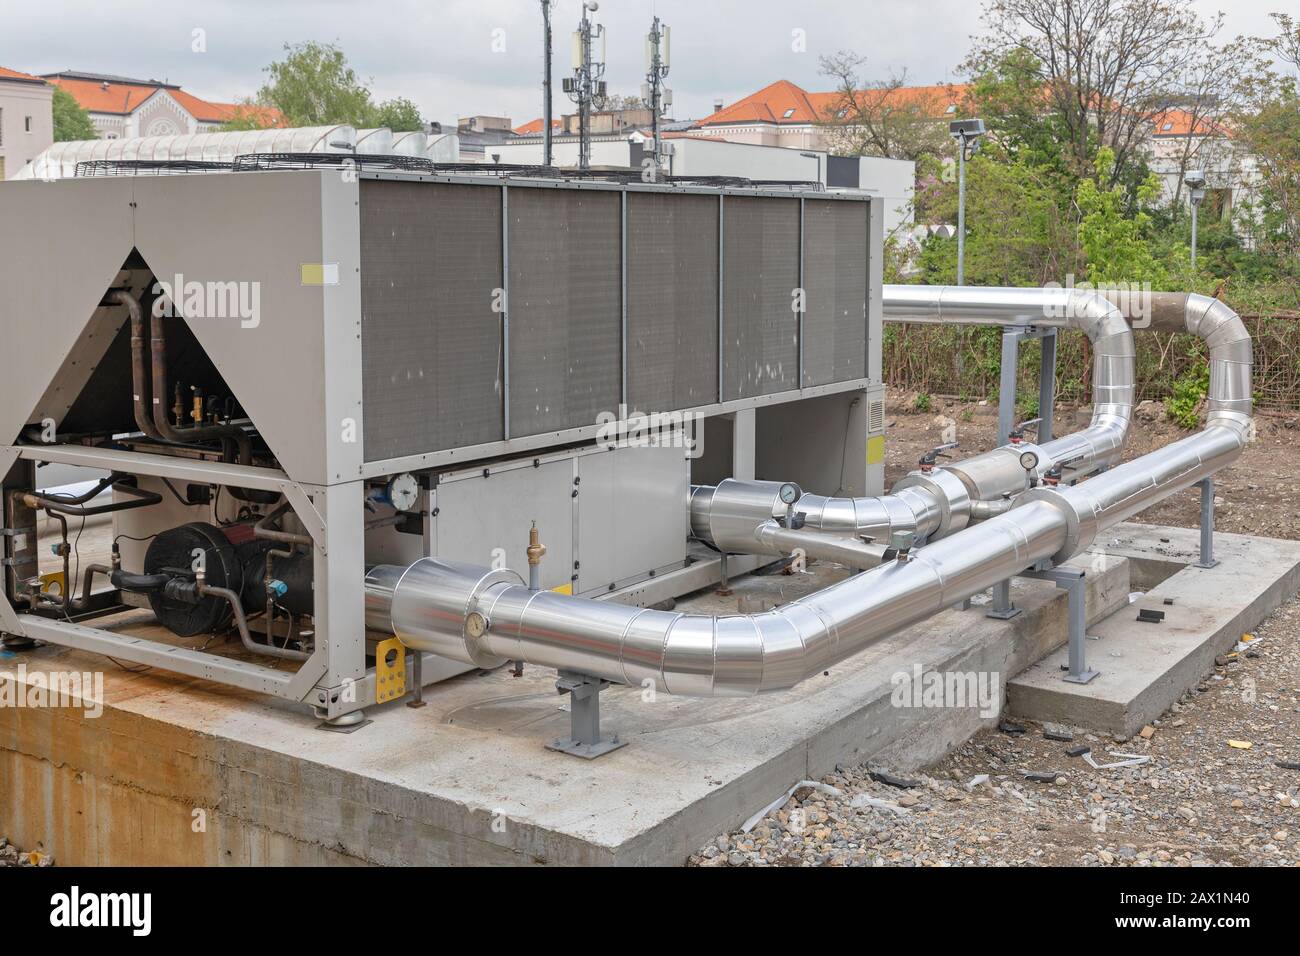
[1008,523,1300,736]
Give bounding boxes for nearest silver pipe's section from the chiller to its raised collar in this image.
[365,502,1066,697]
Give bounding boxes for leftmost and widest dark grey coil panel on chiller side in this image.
[361,179,503,462]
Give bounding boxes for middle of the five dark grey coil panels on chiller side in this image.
[628,193,718,412]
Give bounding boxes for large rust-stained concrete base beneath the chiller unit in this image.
[0,548,1128,865]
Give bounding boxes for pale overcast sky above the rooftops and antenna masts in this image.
[0,0,1295,125]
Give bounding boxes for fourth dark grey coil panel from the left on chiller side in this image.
[722,196,800,399]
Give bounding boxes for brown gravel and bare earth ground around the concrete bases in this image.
[690,393,1300,866]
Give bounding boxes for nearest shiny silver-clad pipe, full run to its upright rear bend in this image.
[365,290,1252,696]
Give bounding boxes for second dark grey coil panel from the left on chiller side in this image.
[508,189,623,436]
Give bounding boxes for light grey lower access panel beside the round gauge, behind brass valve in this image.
[430,459,573,588]
